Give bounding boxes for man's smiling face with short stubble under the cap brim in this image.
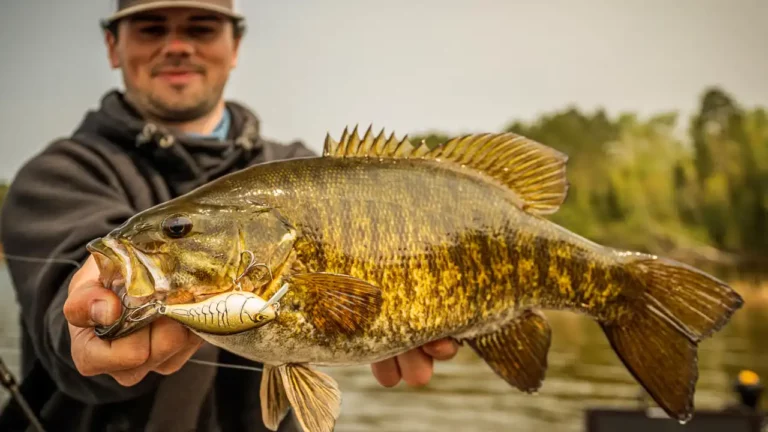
[106,9,239,122]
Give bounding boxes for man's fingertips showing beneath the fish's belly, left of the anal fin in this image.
[371,339,459,387]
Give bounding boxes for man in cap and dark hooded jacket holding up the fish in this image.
[2,0,456,431]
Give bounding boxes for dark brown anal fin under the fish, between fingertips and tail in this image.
[467,309,552,393]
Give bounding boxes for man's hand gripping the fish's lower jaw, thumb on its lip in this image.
[64,256,203,386]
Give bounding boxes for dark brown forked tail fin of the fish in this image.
[600,256,743,423]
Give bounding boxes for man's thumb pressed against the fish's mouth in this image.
[64,280,122,327]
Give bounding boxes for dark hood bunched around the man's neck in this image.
[74,90,262,193]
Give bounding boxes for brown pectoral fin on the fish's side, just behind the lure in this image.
[291,273,382,335]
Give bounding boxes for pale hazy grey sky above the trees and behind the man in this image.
[0,0,768,180]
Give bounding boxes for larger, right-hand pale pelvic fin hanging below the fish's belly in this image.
[278,364,341,432]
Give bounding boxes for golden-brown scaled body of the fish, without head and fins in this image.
[192,154,616,365]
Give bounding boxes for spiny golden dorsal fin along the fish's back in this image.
[323,126,568,215]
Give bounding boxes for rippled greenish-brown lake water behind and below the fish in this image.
[0,267,768,432]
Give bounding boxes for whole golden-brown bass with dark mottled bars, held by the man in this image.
[87,126,743,432]
